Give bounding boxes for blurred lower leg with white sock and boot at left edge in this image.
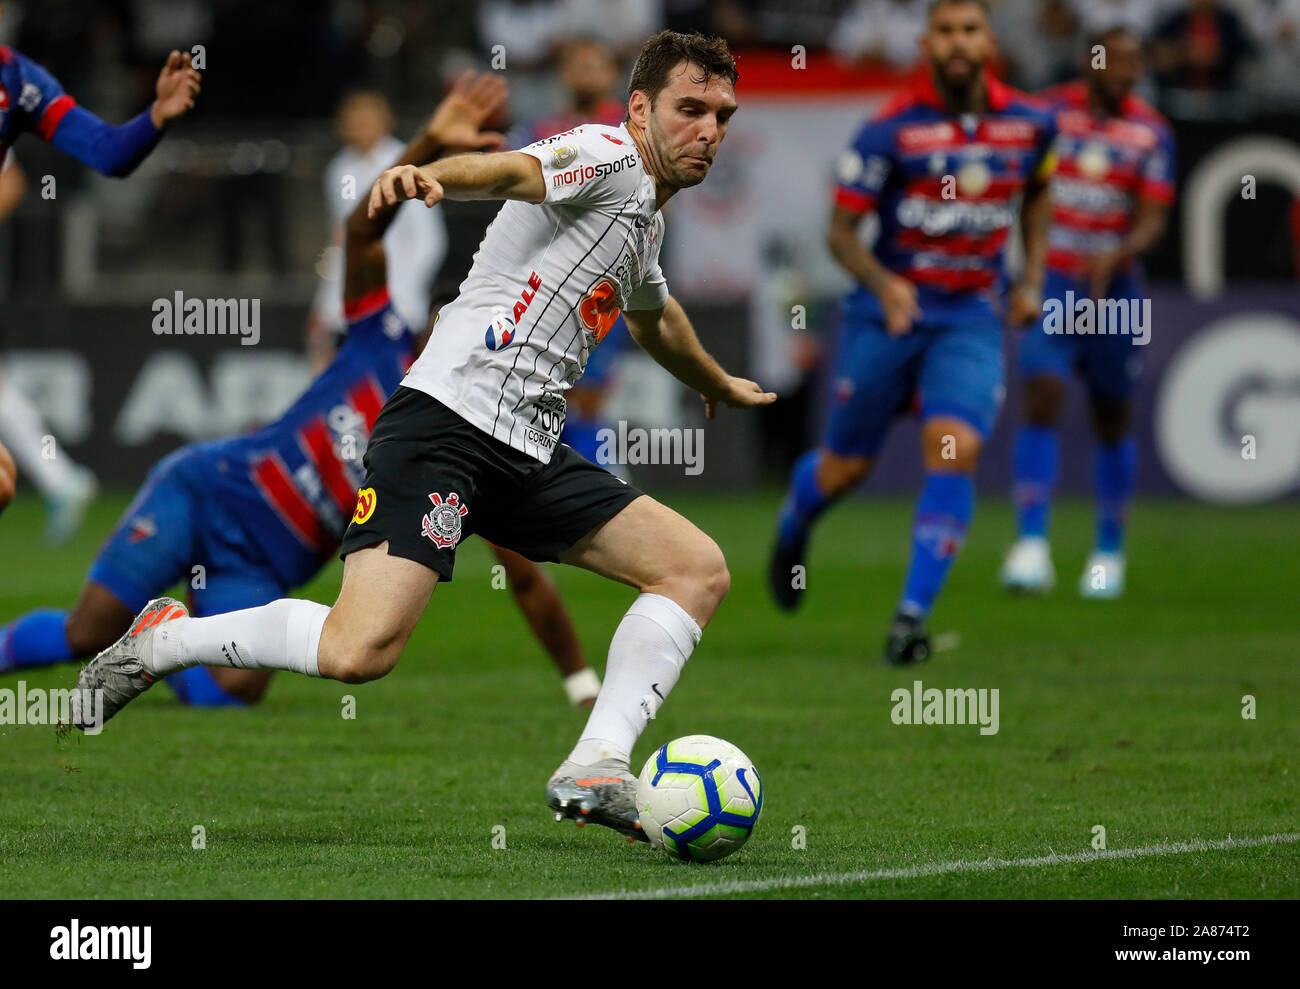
[0,378,99,545]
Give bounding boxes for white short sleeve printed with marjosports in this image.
[520,125,642,209]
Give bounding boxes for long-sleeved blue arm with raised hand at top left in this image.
[31,52,202,178]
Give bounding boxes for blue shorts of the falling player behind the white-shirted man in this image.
[90,447,287,616]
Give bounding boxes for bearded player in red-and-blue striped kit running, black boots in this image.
[768,0,1056,665]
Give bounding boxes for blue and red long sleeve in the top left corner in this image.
[4,48,163,178]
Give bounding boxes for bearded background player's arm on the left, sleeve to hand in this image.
[826,121,920,337]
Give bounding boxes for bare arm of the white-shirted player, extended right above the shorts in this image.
[623,295,776,418]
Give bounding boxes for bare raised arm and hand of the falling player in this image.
[343,73,506,303]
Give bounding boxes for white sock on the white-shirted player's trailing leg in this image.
[150,598,329,677]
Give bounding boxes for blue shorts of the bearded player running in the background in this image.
[824,299,1006,457]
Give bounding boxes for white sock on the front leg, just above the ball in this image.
[569,594,699,765]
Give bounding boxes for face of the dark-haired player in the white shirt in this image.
[646,62,736,188]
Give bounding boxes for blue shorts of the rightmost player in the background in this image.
[1018,272,1143,402]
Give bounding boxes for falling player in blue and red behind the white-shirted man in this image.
[0,75,599,707]
